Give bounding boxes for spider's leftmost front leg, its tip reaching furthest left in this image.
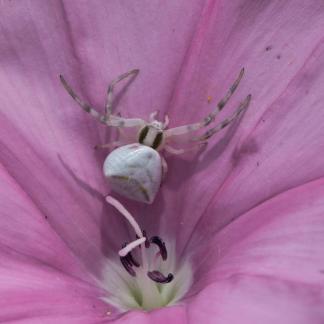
[60,75,145,127]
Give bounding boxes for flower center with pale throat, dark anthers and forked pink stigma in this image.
[103,196,192,311]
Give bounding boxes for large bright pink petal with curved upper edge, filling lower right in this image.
[189,178,324,324]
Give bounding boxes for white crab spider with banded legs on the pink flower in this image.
[60,69,251,204]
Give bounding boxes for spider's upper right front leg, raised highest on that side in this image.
[165,68,244,137]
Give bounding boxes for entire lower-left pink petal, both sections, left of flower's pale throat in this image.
[0,167,109,323]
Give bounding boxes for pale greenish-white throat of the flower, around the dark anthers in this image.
[102,245,193,311]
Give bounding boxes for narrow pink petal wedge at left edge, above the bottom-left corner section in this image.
[0,166,89,280]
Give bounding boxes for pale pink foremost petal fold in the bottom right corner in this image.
[188,275,324,324]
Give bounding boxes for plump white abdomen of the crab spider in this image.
[103,143,162,204]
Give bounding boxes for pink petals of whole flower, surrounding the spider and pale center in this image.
[0,0,324,324]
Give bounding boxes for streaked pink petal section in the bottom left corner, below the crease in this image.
[0,244,107,323]
